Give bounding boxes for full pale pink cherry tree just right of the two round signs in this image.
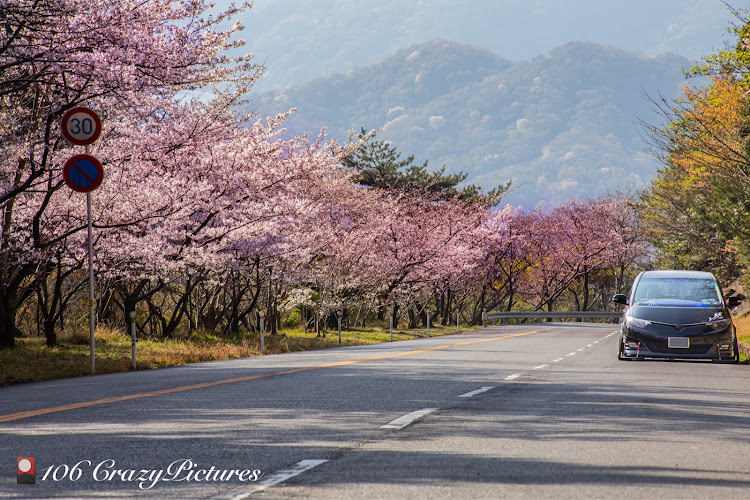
[88,100,356,334]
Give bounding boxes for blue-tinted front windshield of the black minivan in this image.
[633,278,721,307]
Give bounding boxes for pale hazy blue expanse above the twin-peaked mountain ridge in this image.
[214,0,739,90]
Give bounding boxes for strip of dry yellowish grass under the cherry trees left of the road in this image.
[0,326,476,386]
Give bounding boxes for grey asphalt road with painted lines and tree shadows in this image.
[0,323,750,499]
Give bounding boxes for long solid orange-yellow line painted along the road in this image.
[0,330,538,423]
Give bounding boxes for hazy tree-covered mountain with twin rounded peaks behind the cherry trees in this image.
[249,40,692,207]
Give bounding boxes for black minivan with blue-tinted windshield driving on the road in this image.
[612,271,740,363]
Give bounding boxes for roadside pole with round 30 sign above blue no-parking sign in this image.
[60,107,104,374]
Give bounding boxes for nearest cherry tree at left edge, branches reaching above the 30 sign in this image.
[0,0,259,347]
